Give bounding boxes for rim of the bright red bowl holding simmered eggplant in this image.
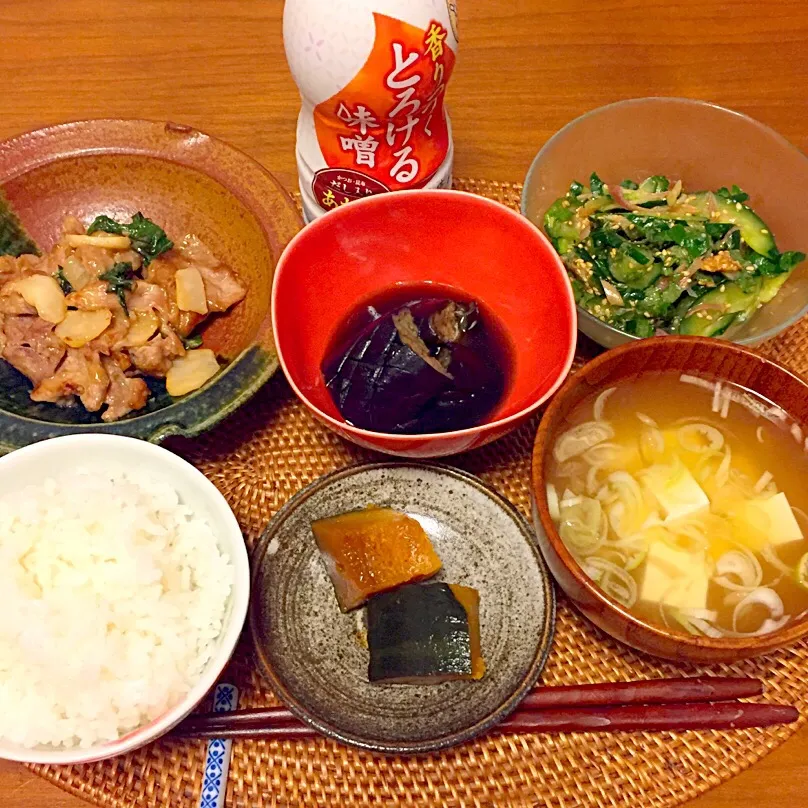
[270,188,578,449]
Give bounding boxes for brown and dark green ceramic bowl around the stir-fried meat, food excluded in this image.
[0,120,302,453]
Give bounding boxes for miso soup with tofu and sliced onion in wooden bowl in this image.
[546,373,808,637]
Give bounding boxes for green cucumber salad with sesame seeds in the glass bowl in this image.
[544,174,805,337]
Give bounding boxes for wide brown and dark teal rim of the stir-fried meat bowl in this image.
[0,118,302,455]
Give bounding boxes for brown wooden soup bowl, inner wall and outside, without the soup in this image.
[532,336,808,663]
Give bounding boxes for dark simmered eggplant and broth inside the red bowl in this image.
[322,283,512,434]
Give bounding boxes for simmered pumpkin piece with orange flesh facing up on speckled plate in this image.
[311,507,441,611]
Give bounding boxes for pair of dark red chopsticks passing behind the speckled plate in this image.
[172,676,799,740]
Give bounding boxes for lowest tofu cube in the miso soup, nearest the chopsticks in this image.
[640,539,710,609]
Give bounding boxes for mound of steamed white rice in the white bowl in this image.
[0,469,233,747]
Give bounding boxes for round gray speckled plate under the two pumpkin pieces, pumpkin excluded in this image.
[250,463,555,753]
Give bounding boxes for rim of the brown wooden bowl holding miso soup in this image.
[530,335,808,653]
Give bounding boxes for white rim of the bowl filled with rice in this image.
[0,432,250,765]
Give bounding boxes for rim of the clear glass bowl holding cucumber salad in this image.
[519,95,808,346]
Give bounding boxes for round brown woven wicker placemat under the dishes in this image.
[31,180,808,808]
